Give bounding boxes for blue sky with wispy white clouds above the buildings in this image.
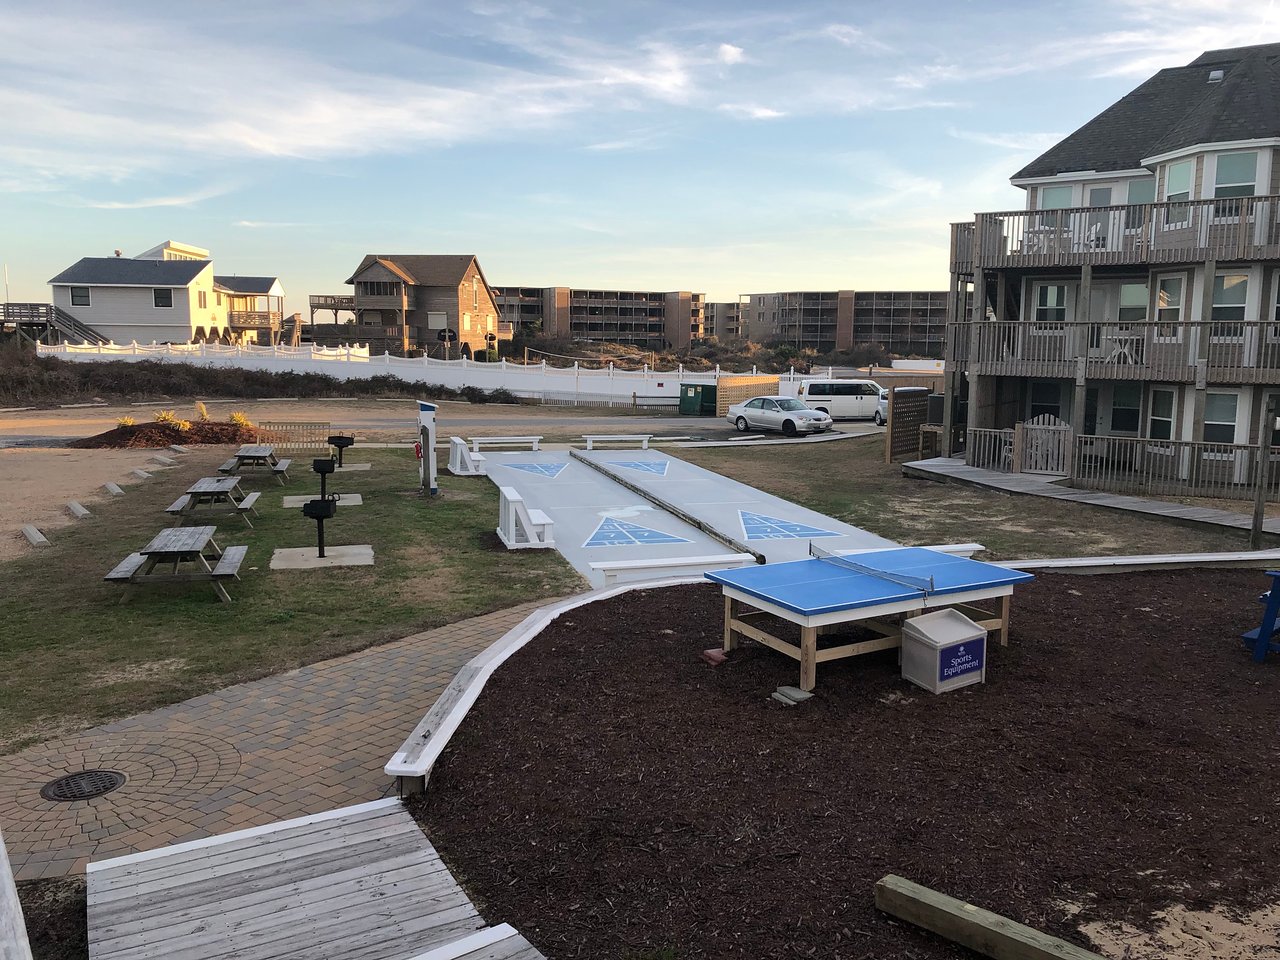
[0,0,1280,311]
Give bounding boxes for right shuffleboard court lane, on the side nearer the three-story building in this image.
[575,451,900,563]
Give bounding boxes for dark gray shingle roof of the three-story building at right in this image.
[1012,44,1280,180]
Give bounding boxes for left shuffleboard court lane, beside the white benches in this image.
[485,451,733,586]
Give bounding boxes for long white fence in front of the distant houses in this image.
[37,343,823,406]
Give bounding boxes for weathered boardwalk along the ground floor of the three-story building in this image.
[902,457,1280,534]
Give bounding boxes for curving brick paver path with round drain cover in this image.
[0,600,549,881]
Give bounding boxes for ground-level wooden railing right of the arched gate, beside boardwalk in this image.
[1075,431,1280,500]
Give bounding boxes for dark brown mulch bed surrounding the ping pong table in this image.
[411,570,1280,960]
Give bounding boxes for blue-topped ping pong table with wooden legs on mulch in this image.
[705,547,1033,690]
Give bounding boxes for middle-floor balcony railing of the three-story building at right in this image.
[947,320,1280,385]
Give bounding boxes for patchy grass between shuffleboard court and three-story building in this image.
[677,435,1248,559]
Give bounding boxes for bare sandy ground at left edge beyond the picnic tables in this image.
[0,447,171,561]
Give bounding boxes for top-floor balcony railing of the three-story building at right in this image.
[951,196,1280,274]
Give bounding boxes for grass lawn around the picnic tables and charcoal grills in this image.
[0,447,585,753]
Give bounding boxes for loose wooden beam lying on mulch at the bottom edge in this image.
[876,874,1103,960]
